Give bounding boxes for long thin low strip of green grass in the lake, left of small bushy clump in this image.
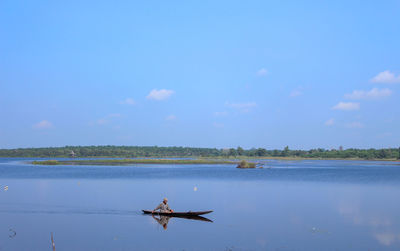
[31,159,237,165]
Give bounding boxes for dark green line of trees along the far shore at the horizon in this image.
[0,146,400,159]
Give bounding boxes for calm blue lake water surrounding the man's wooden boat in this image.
[0,158,400,251]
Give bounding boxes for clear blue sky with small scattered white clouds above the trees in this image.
[0,0,400,149]
